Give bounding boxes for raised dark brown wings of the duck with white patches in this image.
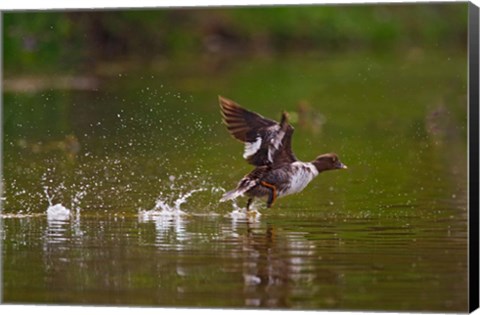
[219,96,297,166]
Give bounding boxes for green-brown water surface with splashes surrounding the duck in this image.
[1,52,468,312]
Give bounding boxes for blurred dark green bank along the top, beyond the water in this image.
[3,3,468,77]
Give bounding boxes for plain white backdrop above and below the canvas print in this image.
[0,0,480,315]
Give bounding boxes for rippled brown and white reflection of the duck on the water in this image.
[238,223,331,308]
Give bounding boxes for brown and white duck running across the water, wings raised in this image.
[218,96,348,212]
